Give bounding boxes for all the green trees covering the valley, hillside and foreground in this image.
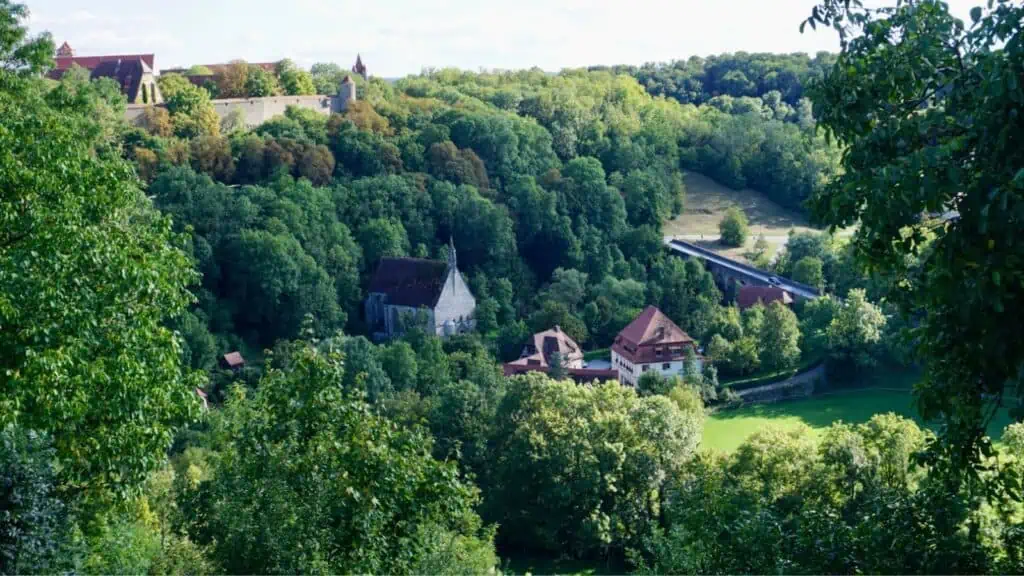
[0,0,1024,574]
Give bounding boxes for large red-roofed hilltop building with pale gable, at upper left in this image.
[47,42,164,104]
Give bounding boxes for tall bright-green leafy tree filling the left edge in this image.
[0,65,202,497]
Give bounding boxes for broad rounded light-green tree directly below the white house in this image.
[483,373,703,559]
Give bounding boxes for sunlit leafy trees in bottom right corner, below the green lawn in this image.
[634,414,1024,574]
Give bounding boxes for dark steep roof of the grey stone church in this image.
[368,258,447,308]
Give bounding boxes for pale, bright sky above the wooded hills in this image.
[20,0,983,78]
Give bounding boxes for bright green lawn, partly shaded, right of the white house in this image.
[702,387,1011,452]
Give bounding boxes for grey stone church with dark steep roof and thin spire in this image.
[366,236,476,339]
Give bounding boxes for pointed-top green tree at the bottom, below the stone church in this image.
[189,345,497,573]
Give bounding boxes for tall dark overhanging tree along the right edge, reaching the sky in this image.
[805,0,1024,461]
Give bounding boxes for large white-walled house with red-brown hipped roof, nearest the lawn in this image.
[611,306,703,385]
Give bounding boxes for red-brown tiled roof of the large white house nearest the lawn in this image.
[611,306,696,364]
